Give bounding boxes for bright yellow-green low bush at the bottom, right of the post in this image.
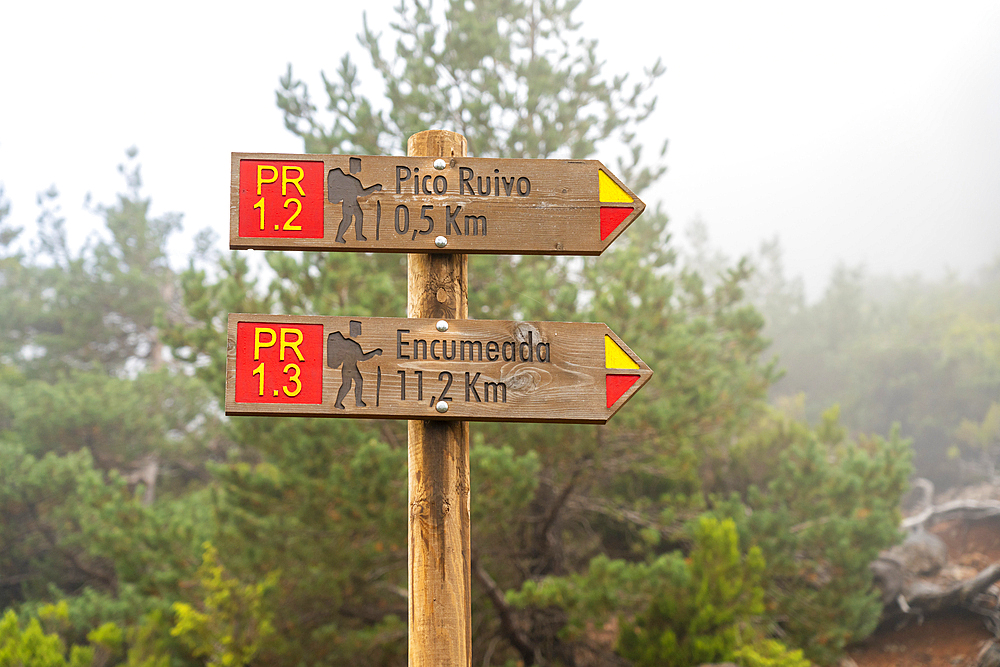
[507,516,809,667]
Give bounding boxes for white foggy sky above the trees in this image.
[0,0,1000,296]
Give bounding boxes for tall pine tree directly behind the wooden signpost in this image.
[175,2,796,664]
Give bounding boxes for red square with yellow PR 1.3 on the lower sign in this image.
[236,322,323,403]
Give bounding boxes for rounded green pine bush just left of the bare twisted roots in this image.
[714,409,912,664]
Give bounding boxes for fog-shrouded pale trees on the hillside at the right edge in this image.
[704,226,1000,488]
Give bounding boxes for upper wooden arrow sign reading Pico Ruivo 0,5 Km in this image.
[229,153,646,255]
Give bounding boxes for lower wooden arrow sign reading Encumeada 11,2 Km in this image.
[226,314,653,424]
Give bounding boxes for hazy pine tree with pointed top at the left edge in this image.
[0,157,227,664]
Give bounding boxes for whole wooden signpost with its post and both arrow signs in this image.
[226,130,652,667]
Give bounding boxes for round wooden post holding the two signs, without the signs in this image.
[406,130,472,667]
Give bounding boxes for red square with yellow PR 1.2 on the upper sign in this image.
[239,160,323,239]
